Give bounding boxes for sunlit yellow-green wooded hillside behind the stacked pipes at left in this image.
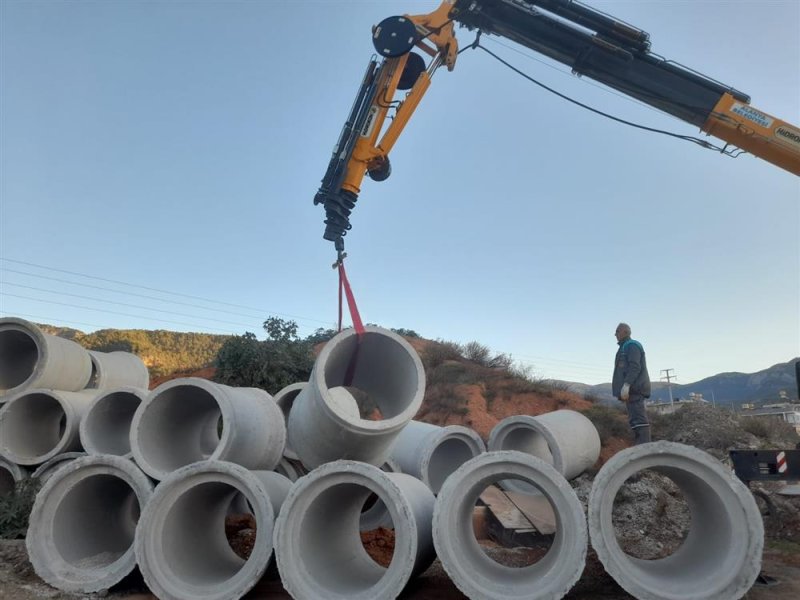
[38,324,230,377]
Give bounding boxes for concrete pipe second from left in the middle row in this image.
[80,387,147,458]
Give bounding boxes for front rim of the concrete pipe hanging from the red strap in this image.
[310,325,425,433]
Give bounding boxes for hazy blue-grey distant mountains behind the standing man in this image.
[565,358,800,407]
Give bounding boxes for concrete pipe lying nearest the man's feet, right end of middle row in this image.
[488,410,600,492]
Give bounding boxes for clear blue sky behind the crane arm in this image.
[0,0,800,383]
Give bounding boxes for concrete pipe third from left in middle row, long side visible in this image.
[130,377,286,479]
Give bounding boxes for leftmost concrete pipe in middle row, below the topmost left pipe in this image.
[0,389,98,465]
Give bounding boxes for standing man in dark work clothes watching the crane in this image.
[611,323,650,446]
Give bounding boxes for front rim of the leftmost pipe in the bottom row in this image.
[25,456,153,593]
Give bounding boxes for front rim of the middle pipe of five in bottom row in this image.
[275,460,419,600]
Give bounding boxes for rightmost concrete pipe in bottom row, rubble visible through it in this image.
[589,442,764,600]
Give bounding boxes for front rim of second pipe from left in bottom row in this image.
[134,460,275,600]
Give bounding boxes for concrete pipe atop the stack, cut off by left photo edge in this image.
[0,317,92,402]
